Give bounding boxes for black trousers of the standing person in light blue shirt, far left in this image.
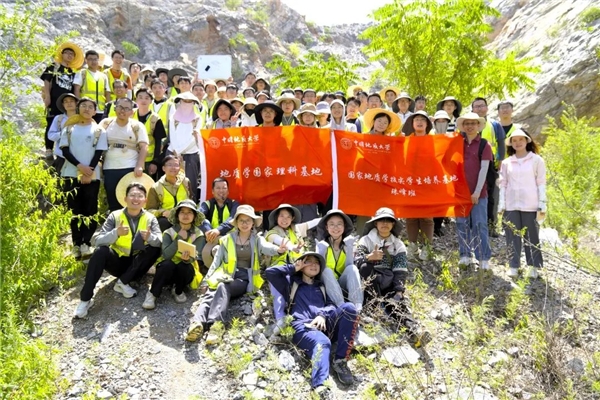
[63,178,100,246]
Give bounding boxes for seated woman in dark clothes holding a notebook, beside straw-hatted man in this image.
[142,200,206,310]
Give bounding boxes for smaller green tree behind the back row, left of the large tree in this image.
[265,51,361,91]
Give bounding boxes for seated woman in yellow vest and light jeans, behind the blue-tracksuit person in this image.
[317,210,364,313]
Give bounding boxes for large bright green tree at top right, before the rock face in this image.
[361,0,537,107]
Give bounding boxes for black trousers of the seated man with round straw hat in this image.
[79,246,160,301]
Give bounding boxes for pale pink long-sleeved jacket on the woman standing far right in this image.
[498,152,546,212]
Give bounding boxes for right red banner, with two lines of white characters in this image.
[333,131,472,218]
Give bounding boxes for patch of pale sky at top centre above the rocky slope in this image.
[282,0,392,25]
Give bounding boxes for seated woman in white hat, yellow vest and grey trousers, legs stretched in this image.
[185,204,285,344]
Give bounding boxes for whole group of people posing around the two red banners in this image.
[42,43,546,398]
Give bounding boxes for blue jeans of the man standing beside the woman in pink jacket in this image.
[456,198,492,261]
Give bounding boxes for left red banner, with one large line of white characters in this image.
[201,126,332,210]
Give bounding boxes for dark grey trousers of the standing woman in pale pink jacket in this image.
[502,211,543,268]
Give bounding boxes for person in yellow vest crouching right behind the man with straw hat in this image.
[147,154,192,232]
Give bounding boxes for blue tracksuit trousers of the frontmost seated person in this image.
[292,303,358,388]
